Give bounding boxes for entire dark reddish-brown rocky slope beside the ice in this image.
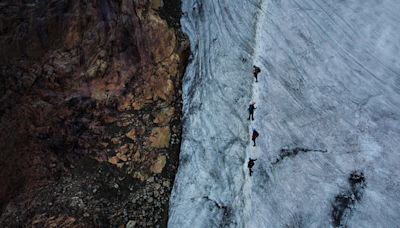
[0,0,189,227]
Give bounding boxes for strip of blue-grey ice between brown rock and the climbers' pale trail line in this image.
[168,0,259,227]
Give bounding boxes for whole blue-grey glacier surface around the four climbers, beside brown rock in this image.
[168,0,400,227]
